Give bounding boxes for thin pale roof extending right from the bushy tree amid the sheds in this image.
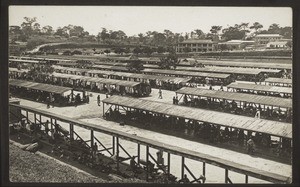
[176,66,262,75]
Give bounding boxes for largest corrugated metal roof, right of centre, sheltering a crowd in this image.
[103,95,292,138]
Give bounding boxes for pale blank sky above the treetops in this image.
[9,6,292,36]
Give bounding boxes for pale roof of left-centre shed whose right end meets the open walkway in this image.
[52,73,141,87]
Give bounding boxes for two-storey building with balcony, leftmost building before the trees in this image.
[176,39,217,53]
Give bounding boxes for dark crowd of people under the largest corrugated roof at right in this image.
[105,108,291,159]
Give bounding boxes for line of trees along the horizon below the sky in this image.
[9,17,292,48]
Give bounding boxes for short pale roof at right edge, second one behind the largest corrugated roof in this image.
[227,82,293,94]
